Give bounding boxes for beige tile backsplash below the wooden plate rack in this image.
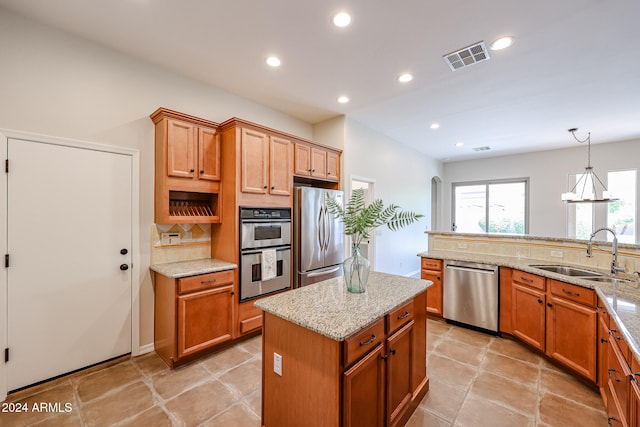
[151,224,211,264]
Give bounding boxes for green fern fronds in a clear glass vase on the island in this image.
[326,189,424,293]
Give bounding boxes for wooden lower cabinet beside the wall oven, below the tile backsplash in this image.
[154,270,235,368]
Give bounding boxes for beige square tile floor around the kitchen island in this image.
[0,321,607,427]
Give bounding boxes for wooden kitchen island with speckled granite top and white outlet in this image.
[256,272,431,427]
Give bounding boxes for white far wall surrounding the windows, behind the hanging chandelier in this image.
[441,140,640,241]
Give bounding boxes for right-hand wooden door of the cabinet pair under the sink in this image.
[547,296,598,382]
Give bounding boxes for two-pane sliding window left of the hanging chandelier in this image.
[452,178,529,234]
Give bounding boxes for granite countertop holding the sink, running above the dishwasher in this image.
[418,251,640,360]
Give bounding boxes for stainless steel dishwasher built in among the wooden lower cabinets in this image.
[442,261,500,333]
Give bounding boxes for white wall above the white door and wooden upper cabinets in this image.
[0,8,312,345]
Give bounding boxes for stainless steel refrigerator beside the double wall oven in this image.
[293,187,344,288]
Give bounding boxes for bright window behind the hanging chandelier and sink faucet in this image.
[567,170,637,243]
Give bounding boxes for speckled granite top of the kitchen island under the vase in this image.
[255,271,433,341]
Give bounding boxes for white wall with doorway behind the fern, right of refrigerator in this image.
[342,118,442,275]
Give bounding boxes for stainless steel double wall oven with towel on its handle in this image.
[240,207,291,301]
